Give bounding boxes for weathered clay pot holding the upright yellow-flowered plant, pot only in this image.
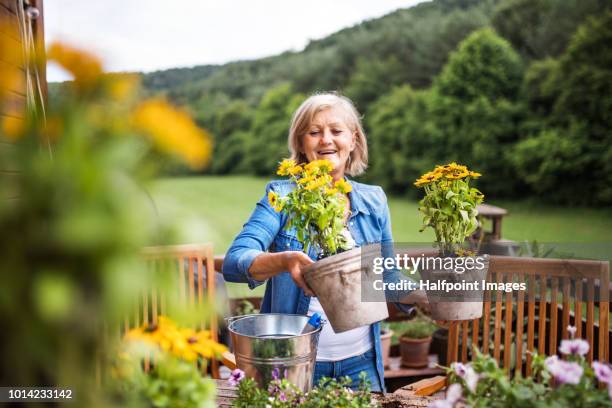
[421,255,489,320]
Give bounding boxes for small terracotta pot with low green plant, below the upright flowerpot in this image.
[400,318,436,368]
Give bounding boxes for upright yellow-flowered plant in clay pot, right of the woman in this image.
[414,163,489,320]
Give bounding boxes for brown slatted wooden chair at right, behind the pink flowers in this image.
[446,256,610,375]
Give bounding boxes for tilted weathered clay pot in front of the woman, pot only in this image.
[304,248,389,333]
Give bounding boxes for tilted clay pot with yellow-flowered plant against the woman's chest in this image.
[268,160,389,333]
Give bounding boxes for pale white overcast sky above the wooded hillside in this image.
[44,0,423,82]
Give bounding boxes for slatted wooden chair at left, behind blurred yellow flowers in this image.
[130,244,219,378]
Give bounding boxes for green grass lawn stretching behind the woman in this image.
[150,176,612,296]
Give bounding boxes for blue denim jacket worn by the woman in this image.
[223,180,411,389]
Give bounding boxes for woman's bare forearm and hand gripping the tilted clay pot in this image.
[249,251,314,296]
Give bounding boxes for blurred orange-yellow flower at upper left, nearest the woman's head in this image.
[132,99,212,168]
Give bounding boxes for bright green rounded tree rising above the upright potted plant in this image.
[430,28,524,196]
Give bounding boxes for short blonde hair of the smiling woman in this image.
[287,92,368,176]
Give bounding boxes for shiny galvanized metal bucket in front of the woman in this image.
[226,313,323,391]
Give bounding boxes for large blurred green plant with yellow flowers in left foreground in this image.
[0,44,215,407]
